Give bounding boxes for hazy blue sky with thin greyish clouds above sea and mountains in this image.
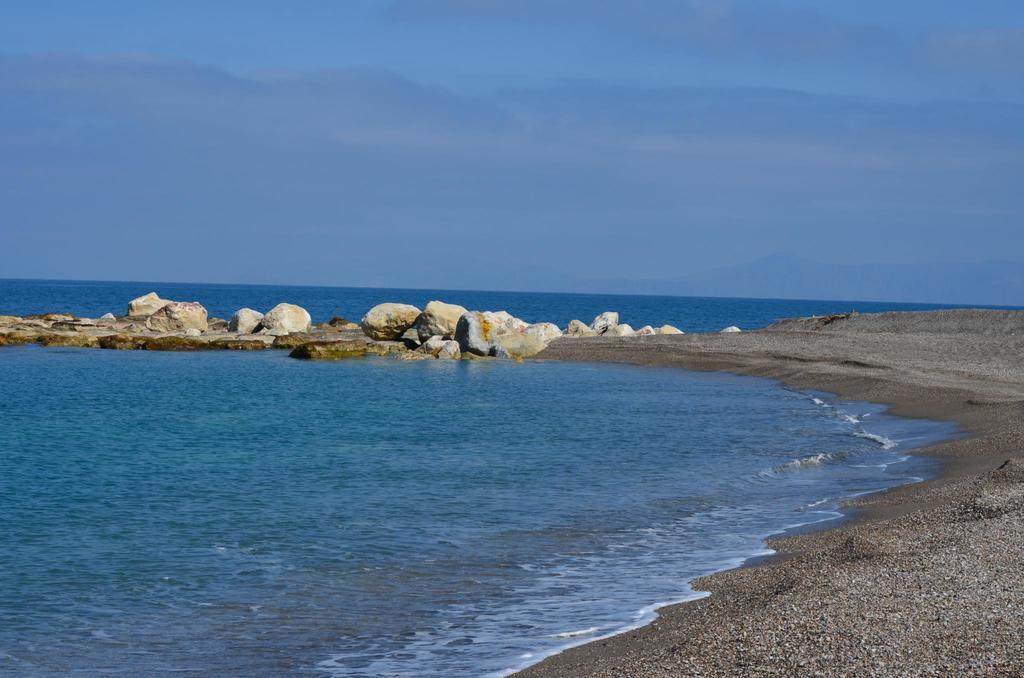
[0,0,1024,289]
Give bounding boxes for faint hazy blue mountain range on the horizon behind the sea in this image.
[452,254,1024,306]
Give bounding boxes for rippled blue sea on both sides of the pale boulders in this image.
[0,281,978,676]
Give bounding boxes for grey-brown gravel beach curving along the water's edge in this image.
[518,310,1024,677]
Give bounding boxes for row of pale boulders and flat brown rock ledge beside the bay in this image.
[0,292,739,361]
